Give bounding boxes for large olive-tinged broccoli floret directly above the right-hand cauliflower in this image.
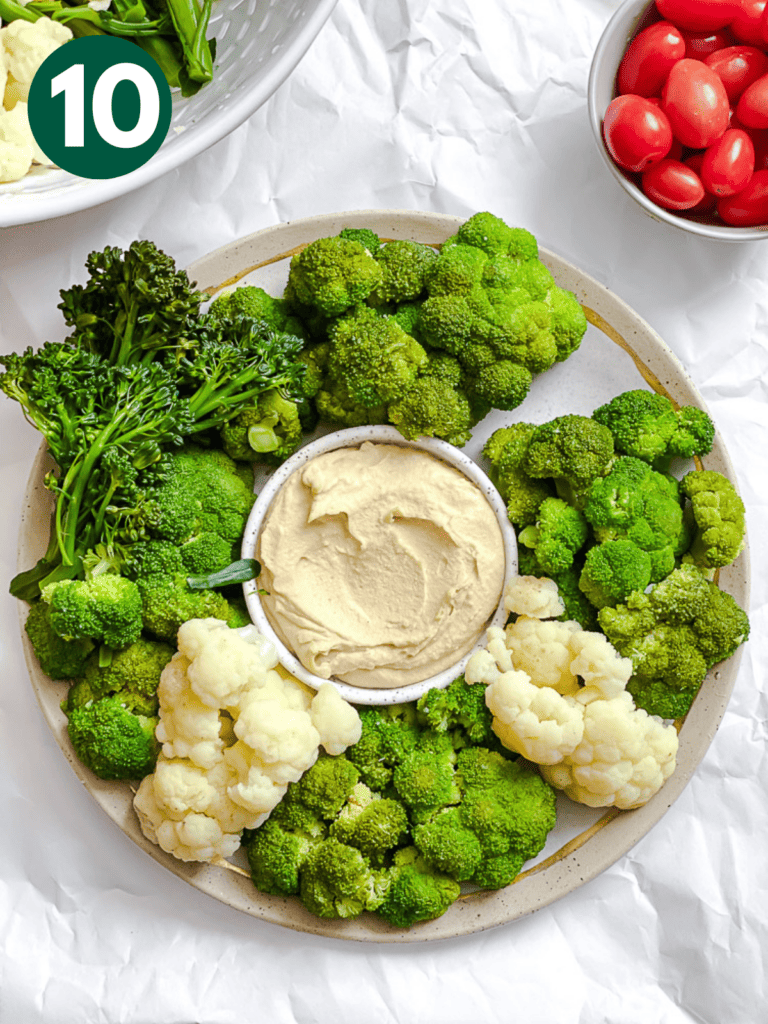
[598,564,750,718]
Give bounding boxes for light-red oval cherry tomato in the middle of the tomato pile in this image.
[662,57,730,150]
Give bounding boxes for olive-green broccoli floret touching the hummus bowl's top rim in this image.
[389,376,476,447]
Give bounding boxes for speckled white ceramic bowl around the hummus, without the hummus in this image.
[242,426,517,705]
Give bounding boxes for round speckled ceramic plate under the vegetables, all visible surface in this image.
[18,211,749,942]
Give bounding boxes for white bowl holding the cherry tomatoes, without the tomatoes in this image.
[587,0,768,242]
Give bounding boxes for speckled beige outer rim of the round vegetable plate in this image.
[18,210,750,943]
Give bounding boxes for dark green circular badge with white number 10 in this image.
[29,36,171,178]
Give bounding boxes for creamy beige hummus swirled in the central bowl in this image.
[257,441,505,687]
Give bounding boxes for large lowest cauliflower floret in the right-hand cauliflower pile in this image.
[541,691,678,809]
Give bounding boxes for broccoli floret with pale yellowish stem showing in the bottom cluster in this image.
[330,782,409,867]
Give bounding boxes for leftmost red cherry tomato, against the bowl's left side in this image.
[603,95,672,171]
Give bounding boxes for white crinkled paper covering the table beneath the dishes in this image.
[0,0,768,1024]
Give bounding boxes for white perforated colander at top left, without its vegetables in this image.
[0,0,337,227]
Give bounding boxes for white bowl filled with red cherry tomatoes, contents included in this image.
[588,0,768,242]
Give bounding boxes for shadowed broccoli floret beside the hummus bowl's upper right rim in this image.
[482,423,555,526]
